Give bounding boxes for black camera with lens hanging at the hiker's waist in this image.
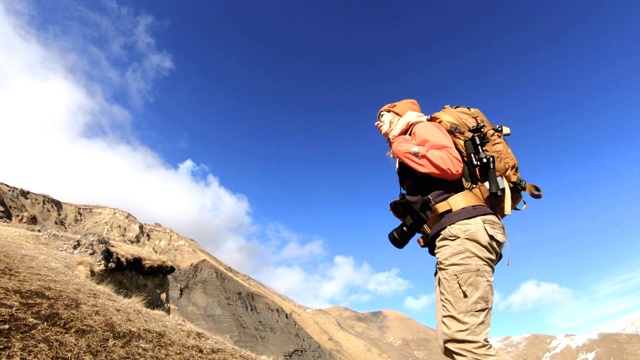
[389,194,426,249]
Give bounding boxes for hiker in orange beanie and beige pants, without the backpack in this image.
[375,99,510,360]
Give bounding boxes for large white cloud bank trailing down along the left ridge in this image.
[0,1,409,307]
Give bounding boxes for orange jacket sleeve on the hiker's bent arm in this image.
[391,122,462,180]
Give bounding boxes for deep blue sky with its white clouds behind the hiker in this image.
[0,0,640,336]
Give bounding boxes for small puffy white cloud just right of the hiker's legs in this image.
[496,280,573,311]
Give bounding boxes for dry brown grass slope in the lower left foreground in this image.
[0,224,264,360]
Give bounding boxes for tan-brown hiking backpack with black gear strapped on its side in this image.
[428,105,542,218]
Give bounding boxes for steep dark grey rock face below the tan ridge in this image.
[170,260,333,360]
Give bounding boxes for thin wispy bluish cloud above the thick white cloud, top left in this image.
[7,0,174,110]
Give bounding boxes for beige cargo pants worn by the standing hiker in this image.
[435,215,511,360]
